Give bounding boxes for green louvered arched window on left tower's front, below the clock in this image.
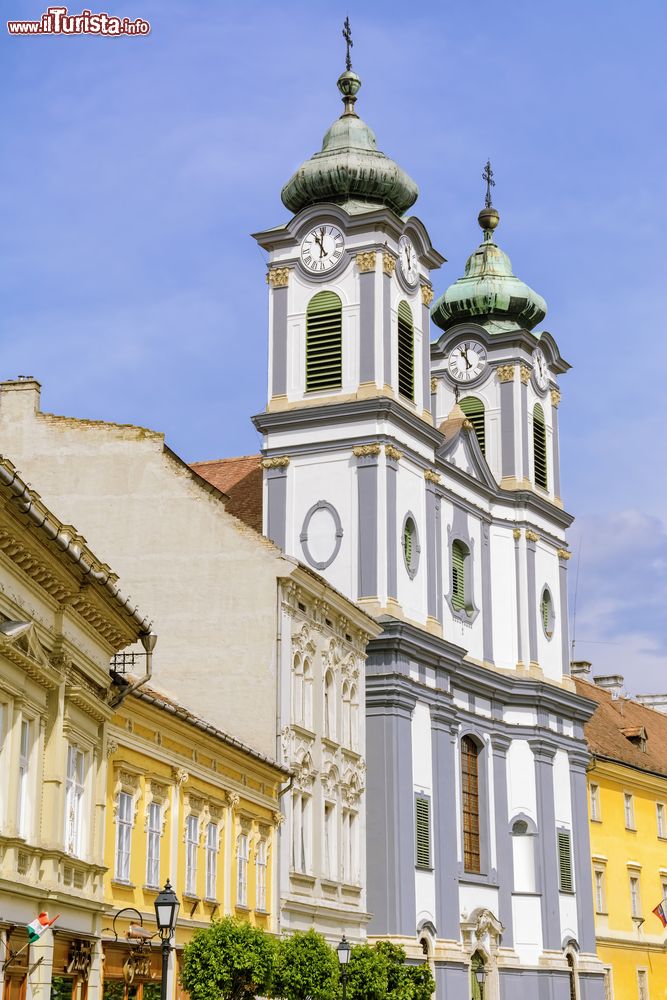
[306,292,343,392]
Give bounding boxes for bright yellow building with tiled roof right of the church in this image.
[576,664,667,1000]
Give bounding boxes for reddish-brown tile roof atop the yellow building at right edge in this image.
[574,677,667,776]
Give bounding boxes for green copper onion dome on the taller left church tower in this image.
[281,68,419,215]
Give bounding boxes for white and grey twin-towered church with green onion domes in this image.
[254,56,604,1000]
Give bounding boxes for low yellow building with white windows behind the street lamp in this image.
[102,687,289,1000]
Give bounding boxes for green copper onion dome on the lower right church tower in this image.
[431,195,547,333]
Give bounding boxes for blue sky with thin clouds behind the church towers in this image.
[0,0,667,691]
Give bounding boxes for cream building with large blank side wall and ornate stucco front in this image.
[0,379,380,941]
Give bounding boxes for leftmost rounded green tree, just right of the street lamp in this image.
[181,917,275,1000]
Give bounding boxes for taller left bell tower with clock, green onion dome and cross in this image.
[254,39,444,621]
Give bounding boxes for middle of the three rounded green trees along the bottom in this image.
[273,930,338,1000]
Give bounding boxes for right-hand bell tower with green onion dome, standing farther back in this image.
[431,163,570,507]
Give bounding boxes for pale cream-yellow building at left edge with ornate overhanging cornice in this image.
[0,458,150,1000]
